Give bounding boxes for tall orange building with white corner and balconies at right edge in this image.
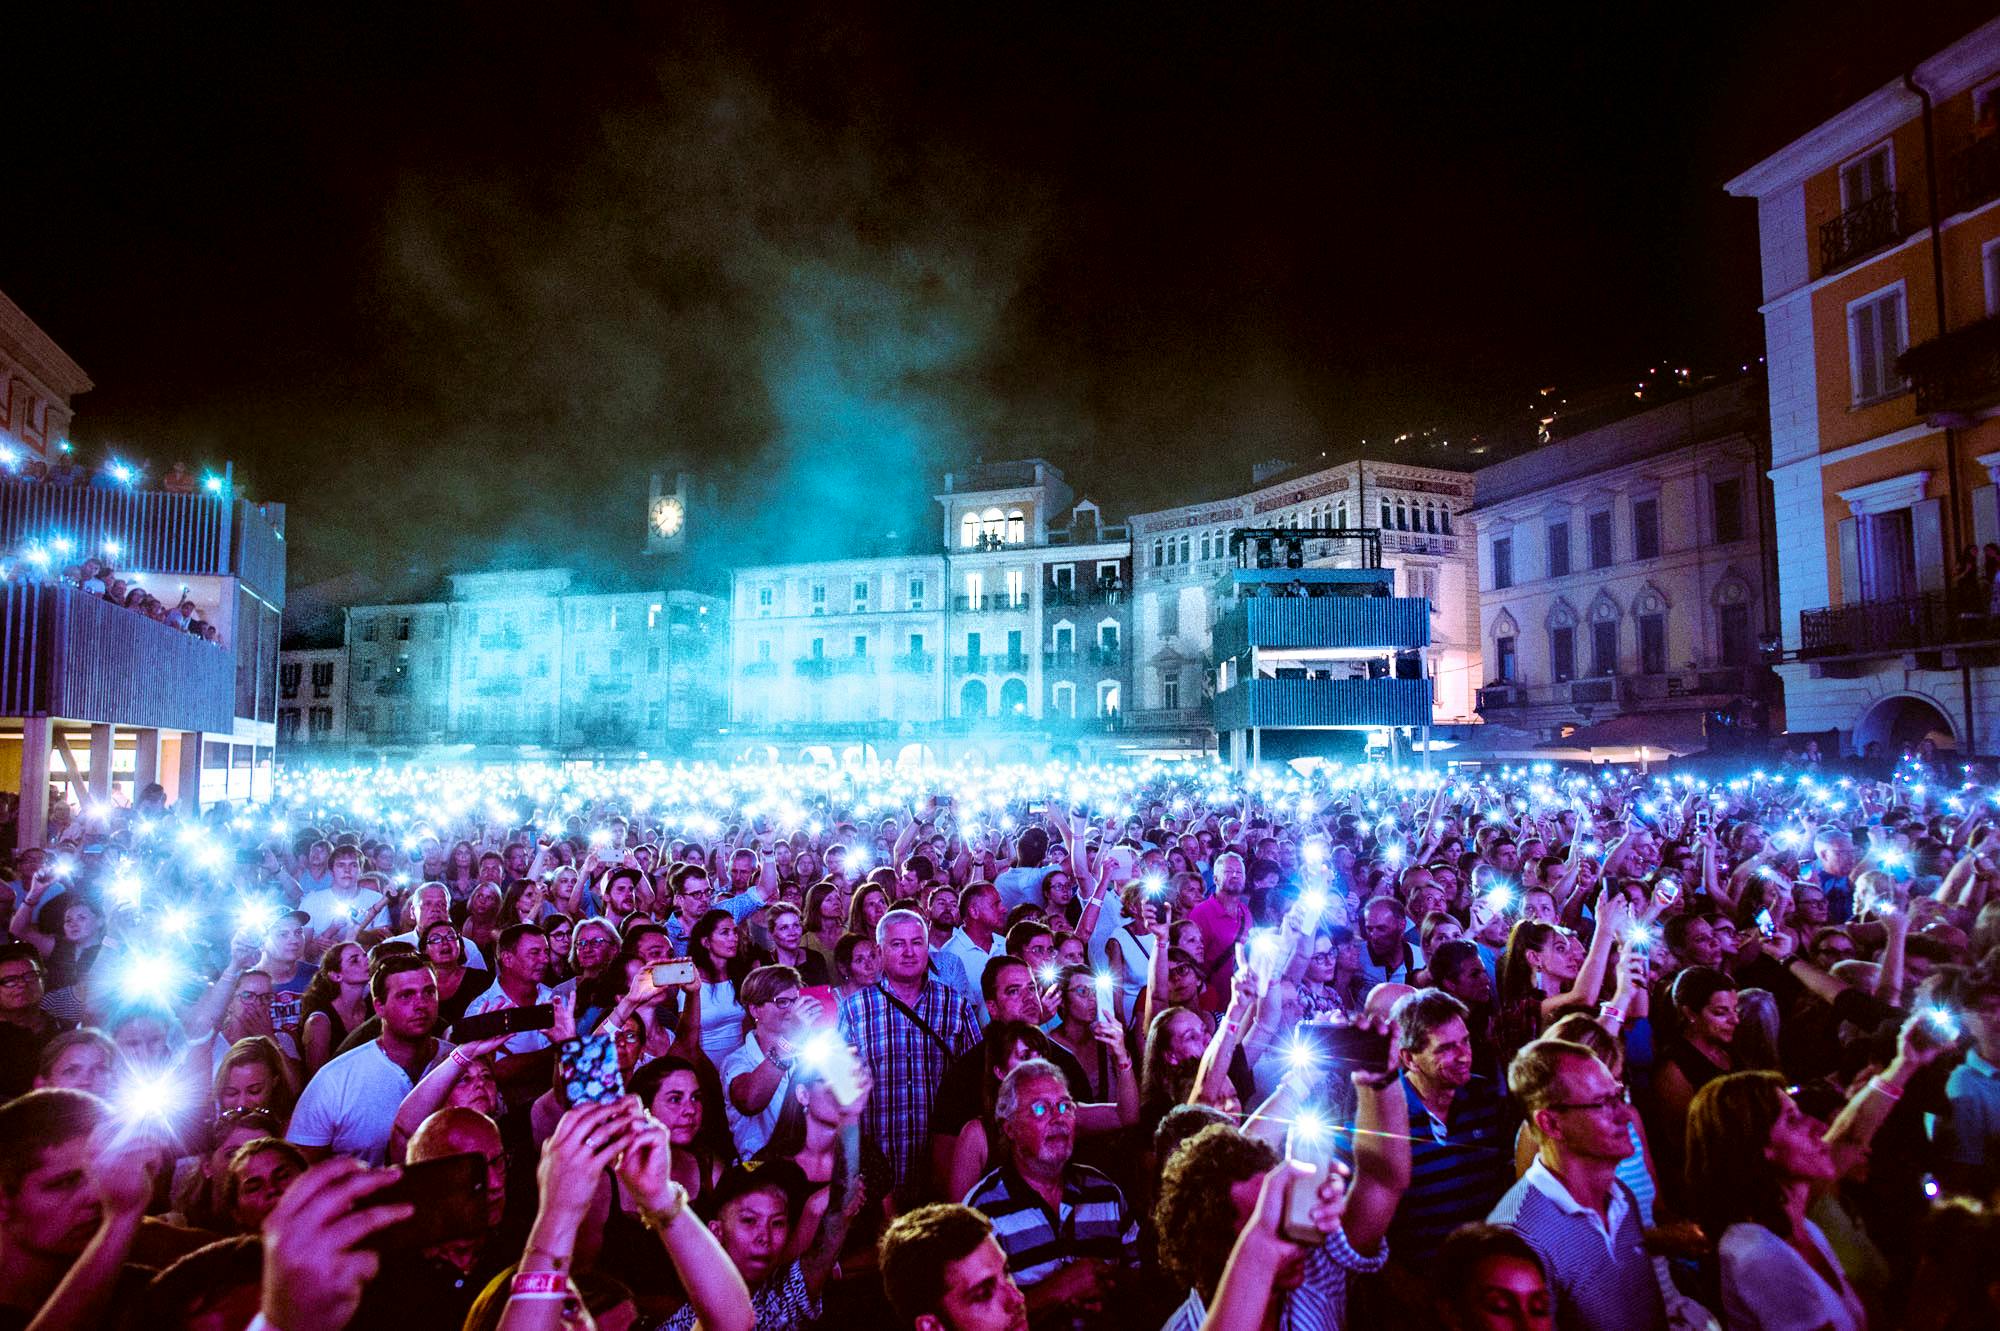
[1728,20,2000,755]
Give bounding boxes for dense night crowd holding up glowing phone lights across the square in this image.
[0,761,2000,1331]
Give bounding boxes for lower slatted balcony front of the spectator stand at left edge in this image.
[0,579,236,733]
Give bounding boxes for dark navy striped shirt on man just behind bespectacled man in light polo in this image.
[1388,1077,1514,1263]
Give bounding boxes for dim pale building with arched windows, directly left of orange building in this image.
[1472,380,1776,747]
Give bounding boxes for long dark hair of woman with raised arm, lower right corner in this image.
[1688,1071,1790,1243]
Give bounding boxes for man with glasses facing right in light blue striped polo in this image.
[1488,1039,1666,1331]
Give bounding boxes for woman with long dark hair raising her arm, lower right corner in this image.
[1688,1015,1942,1331]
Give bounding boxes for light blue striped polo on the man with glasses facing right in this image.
[1486,1159,1666,1331]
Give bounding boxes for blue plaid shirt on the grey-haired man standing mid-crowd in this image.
[840,975,980,1201]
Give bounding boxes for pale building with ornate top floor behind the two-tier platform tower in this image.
[1132,460,1480,729]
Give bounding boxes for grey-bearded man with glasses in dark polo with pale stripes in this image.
[966,1059,1138,1327]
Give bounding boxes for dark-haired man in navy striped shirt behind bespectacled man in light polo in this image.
[1388,989,1514,1275]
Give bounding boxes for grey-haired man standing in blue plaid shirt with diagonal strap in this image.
[840,911,980,1205]
